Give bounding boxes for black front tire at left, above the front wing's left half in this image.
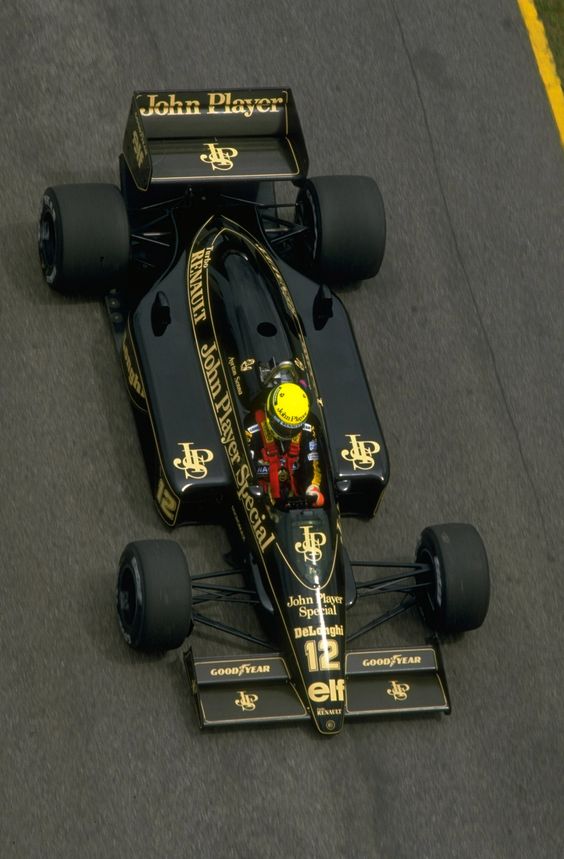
[117,540,192,651]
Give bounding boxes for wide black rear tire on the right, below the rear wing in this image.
[298,176,386,285]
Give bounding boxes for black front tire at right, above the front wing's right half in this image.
[416,524,490,633]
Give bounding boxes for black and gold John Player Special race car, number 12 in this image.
[39,89,489,734]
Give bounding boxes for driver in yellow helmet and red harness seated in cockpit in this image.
[246,382,325,507]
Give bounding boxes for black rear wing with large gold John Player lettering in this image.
[123,89,308,191]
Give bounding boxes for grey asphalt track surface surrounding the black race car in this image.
[0,0,564,859]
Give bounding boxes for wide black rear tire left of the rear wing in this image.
[38,184,129,296]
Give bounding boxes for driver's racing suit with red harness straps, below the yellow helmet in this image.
[246,409,323,502]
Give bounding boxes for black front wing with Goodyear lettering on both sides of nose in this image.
[184,645,450,728]
